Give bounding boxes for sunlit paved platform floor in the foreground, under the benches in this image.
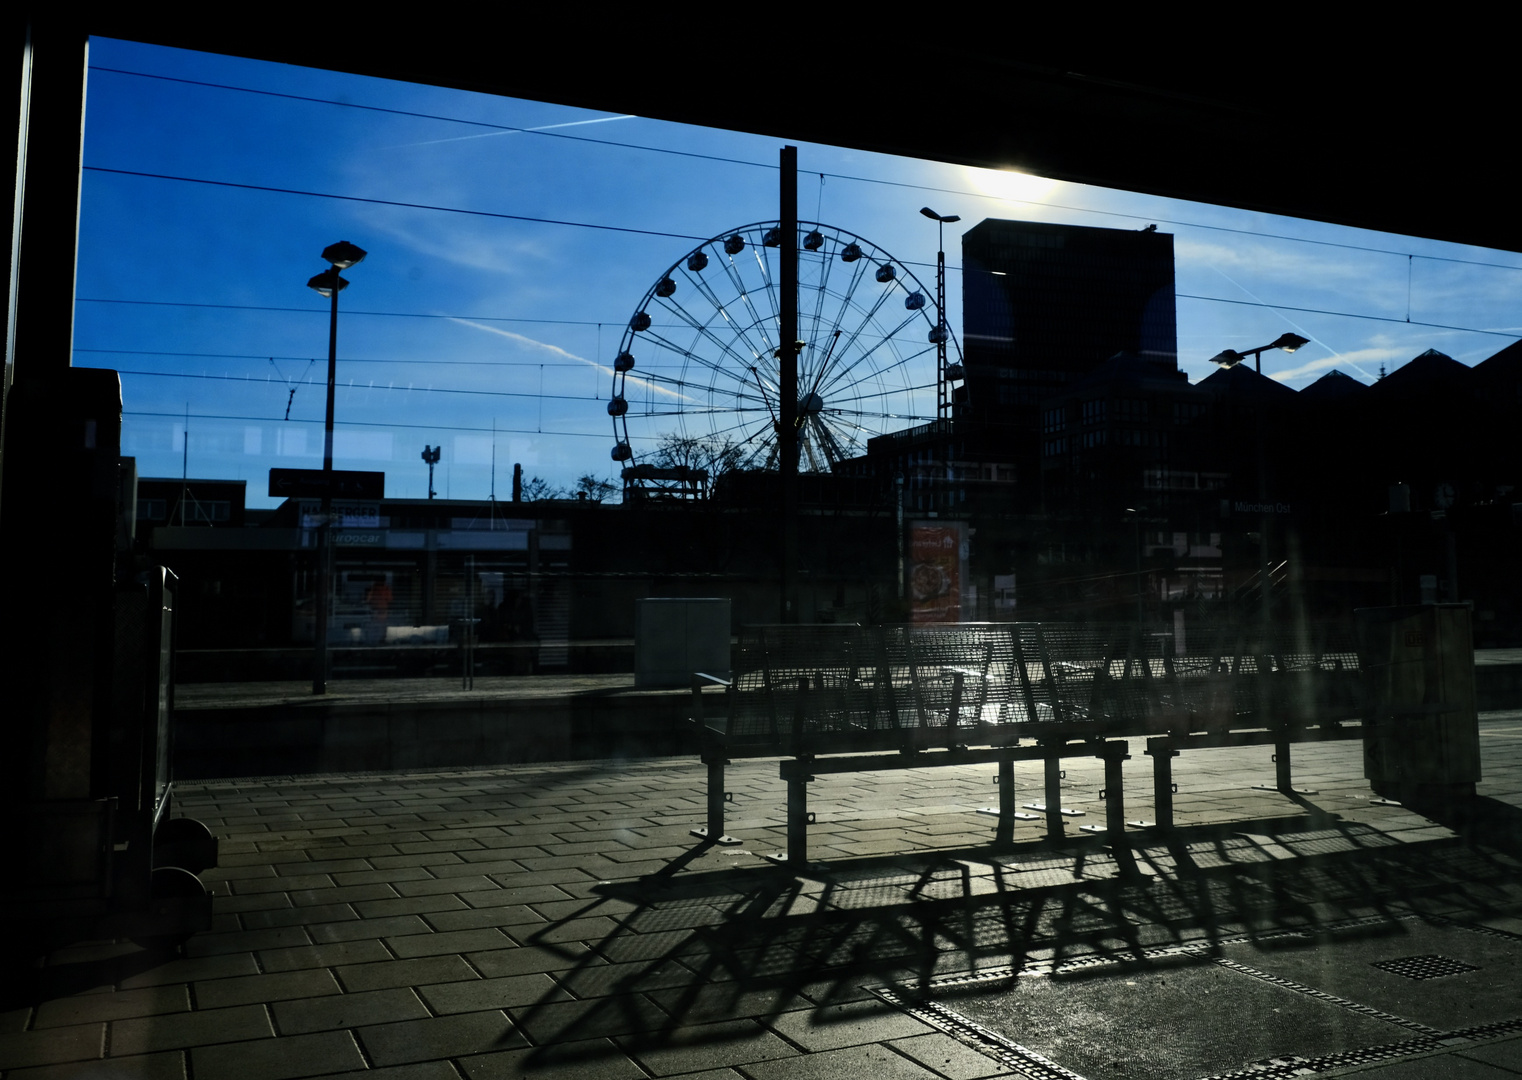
[0,713,1522,1080]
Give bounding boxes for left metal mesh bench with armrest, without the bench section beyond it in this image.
[693,624,1144,866]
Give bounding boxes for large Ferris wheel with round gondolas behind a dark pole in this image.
[607,222,962,485]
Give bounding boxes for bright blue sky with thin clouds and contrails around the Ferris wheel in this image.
[75,40,1522,507]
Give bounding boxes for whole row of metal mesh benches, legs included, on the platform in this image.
[693,622,1361,866]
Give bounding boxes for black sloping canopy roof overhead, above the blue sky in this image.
[71,19,1522,251]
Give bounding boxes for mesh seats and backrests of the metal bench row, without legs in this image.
[706,622,1361,753]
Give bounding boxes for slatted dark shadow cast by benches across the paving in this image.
[511,796,1522,1053]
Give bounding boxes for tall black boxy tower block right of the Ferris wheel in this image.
[954,218,1178,435]
